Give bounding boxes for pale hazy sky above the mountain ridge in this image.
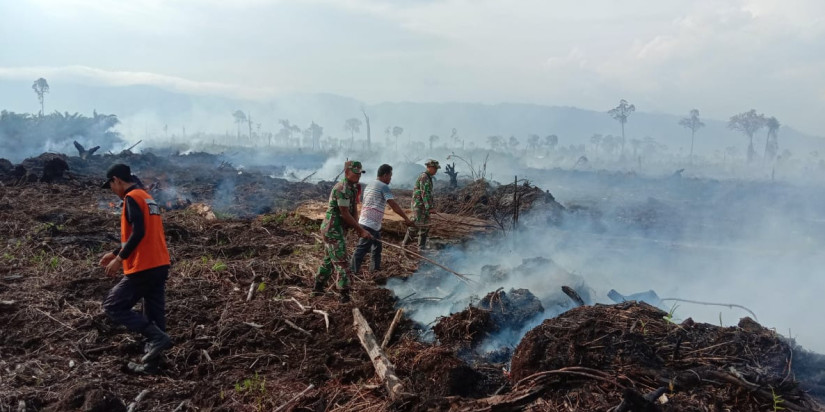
[0,0,825,136]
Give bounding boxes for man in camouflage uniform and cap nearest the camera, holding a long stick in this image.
[312,160,372,303]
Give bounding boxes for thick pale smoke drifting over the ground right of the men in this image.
[388,167,825,352]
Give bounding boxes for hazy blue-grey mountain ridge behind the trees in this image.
[0,80,825,154]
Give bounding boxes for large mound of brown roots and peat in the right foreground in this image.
[509,302,821,411]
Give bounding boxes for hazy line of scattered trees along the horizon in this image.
[9,77,792,167]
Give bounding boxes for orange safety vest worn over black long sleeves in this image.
[120,189,171,275]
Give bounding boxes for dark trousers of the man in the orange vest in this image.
[103,266,169,332]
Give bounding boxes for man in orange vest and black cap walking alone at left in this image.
[100,163,172,373]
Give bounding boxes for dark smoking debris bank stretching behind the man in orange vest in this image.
[0,150,328,218]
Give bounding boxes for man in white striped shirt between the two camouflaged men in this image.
[352,164,413,273]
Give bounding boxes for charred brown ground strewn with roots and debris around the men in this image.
[0,150,825,411]
